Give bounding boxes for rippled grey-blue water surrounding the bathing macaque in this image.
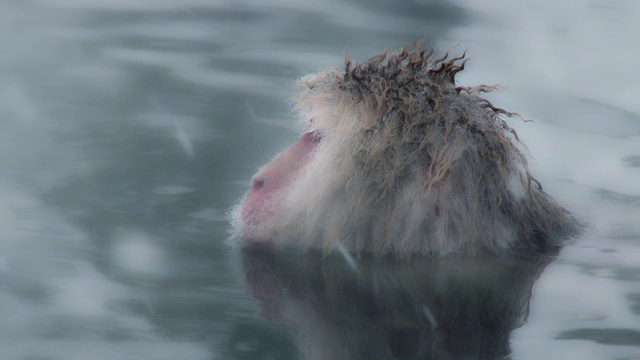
[0,0,640,360]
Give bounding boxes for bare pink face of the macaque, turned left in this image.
[240,132,321,241]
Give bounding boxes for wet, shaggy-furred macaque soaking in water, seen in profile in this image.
[233,42,579,256]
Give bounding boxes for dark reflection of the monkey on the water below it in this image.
[242,245,553,360]
